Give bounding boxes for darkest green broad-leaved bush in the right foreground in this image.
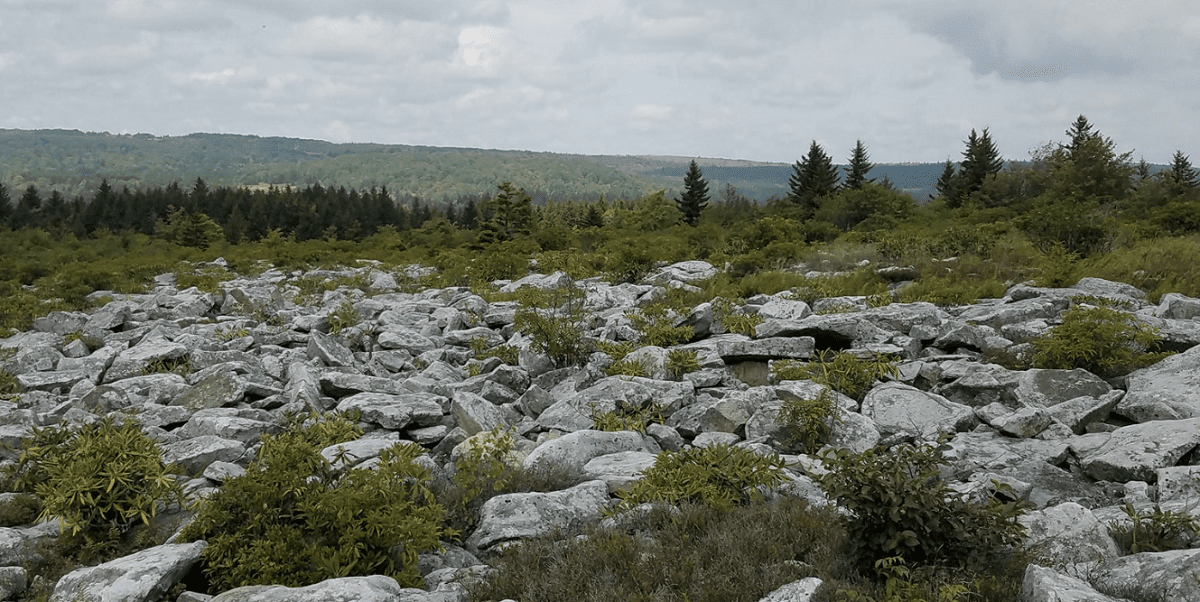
[817,444,1025,572]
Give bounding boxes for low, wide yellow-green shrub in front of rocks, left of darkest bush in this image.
[608,445,784,513]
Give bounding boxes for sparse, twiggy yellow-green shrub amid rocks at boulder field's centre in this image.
[512,283,592,367]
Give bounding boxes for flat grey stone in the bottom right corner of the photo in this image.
[1091,549,1200,601]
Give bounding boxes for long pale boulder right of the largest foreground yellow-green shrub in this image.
[467,481,608,550]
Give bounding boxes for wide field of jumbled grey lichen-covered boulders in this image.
[0,261,1200,602]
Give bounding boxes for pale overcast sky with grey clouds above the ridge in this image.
[0,0,1200,163]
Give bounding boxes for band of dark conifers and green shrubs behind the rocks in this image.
[0,115,1200,335]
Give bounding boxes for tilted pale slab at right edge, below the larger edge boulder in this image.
[1080,419,1200,483]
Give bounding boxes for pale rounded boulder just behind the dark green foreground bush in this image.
[863,383,977,441]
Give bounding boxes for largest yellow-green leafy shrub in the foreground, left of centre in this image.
[180,415,444,591]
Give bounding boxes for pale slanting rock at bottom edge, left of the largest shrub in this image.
[50,541,208,602]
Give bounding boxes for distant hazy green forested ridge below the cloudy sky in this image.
[0,130,942,205]
